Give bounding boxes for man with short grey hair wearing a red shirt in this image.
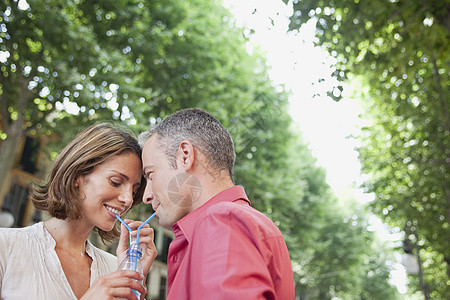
[140,108,294,300]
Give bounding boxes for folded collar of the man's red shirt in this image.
[172,185,251,241]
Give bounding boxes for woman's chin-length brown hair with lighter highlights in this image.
[30,123,146,241]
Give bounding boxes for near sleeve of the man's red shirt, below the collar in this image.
[189,206,275,299]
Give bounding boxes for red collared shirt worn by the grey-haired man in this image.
[167,186,294,300]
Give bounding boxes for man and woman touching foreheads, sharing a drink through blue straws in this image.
[0,108,294,300]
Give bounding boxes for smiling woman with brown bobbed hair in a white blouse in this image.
[0,124,157,300]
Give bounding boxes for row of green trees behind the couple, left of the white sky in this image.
[0,0,404,297]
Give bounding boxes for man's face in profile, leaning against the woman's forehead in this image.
[142,135,192,230]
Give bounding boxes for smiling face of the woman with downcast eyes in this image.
[76,153,142,231]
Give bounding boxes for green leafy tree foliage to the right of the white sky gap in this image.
[285,0,450,299]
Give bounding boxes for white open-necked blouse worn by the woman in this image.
[0,222,117,300]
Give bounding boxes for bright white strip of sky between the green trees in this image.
[223,0,407,293]
